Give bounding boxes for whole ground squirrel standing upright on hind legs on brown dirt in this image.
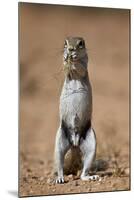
[55,37,98,183]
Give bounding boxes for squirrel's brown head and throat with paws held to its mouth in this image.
[63,37,88,79]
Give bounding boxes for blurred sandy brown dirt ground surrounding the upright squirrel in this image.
[19,3,130,196]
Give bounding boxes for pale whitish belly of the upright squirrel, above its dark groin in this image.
[60,79,92,126]
